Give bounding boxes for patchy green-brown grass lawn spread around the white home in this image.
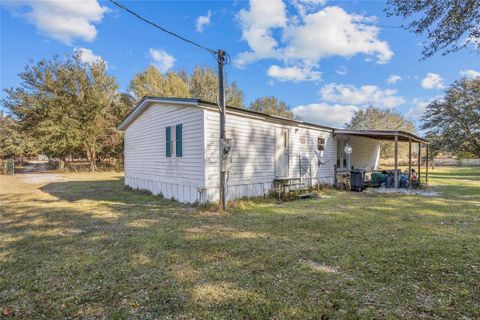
[0,168,480,319]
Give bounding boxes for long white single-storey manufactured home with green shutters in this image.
[118,97,426,203]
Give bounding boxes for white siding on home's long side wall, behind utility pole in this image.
[205,109,335,200]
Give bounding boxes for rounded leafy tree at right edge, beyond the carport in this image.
[422,77,480,158]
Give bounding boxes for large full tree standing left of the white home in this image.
[2,53,130,171]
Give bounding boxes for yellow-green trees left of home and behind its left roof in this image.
[0,52,293,171]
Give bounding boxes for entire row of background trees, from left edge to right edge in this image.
[0,53,480,171]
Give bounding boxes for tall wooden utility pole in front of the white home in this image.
[217,49,227,210]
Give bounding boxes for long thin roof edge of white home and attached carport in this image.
[117,96,428,143]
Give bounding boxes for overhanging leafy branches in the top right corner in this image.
[385,0,480,58]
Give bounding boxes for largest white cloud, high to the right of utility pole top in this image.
[234,0,393,70]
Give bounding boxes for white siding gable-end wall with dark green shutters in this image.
[125,104,205,202]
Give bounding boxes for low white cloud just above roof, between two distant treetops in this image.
[291,103,359,127]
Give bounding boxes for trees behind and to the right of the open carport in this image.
[345,76,480,158]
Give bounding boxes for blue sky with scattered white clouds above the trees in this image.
[0,0,480,126]
